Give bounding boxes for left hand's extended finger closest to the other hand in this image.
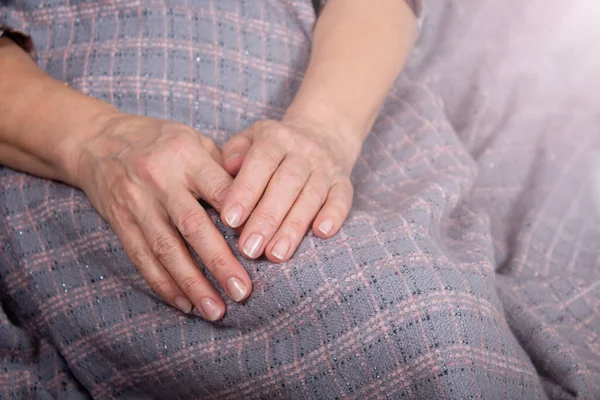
[164,192,252,301]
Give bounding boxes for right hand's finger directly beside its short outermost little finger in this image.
[265,173,331,262]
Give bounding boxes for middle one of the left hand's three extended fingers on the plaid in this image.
[137,205,225,321]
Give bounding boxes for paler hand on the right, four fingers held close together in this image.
[222,119,360,262]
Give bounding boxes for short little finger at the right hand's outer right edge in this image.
[313,178,354,239]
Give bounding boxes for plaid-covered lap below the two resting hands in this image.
[0,82,541,398]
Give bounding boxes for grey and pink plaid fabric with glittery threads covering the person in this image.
[0,0,600,399]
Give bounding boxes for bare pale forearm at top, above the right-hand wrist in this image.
[287,0,416,158]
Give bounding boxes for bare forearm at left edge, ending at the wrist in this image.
[0,38,114,185]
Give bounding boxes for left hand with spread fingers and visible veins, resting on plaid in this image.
[76,114,252,321]
